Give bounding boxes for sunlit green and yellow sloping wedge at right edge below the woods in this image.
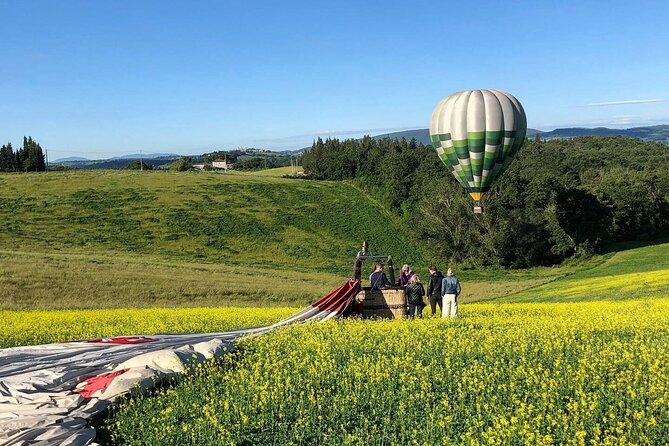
[502,243,669,302]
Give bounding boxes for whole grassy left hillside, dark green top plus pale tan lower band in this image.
[0,171,426,309]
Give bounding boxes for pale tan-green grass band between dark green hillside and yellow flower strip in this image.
[0,251,344,310]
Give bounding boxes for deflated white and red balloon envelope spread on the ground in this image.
[0,282,359,446]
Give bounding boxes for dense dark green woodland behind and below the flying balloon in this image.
[303,137,669,267]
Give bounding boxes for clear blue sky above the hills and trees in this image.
[0,0,669,159]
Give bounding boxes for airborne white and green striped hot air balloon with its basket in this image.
[430,90,527,213]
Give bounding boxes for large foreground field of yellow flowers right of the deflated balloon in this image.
[103,297,669,445]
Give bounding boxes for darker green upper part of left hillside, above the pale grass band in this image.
[0,172,425,268]
